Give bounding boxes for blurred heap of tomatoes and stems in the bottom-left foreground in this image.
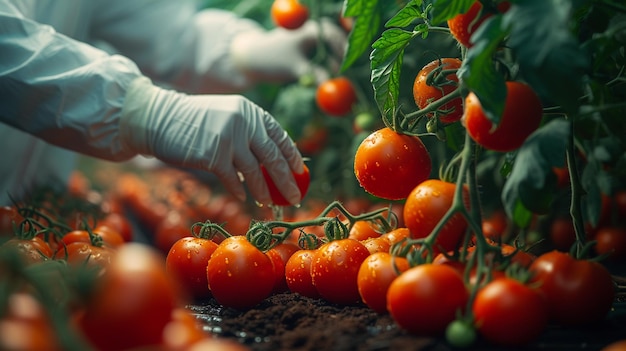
[0,176,255,351]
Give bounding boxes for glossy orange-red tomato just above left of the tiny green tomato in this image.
[387,264,469,336]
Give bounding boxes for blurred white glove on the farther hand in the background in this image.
[231,19,347,83]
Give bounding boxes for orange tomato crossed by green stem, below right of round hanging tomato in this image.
[404,179,469,252]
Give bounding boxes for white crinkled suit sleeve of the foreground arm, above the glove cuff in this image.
[0,2,141,161]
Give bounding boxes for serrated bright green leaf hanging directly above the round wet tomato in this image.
[370,28,414,125]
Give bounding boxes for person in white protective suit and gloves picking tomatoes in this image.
[0,0,343,204]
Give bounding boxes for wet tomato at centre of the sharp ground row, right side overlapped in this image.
[311,239,370,304]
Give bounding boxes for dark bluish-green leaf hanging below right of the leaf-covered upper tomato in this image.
[502,119,570,217]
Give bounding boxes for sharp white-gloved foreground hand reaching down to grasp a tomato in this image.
[120,78,303,204]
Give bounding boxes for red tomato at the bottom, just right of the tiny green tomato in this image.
[472,278,548,346]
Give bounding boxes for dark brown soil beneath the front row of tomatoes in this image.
[189,284,626,351]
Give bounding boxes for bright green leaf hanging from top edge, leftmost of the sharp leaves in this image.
[340,0,382,72]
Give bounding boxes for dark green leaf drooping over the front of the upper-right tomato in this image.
[457,15,507,124]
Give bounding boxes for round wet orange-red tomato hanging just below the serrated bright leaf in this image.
[354,128,432,200]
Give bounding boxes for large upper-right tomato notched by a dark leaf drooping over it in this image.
[463,82,543,152]
